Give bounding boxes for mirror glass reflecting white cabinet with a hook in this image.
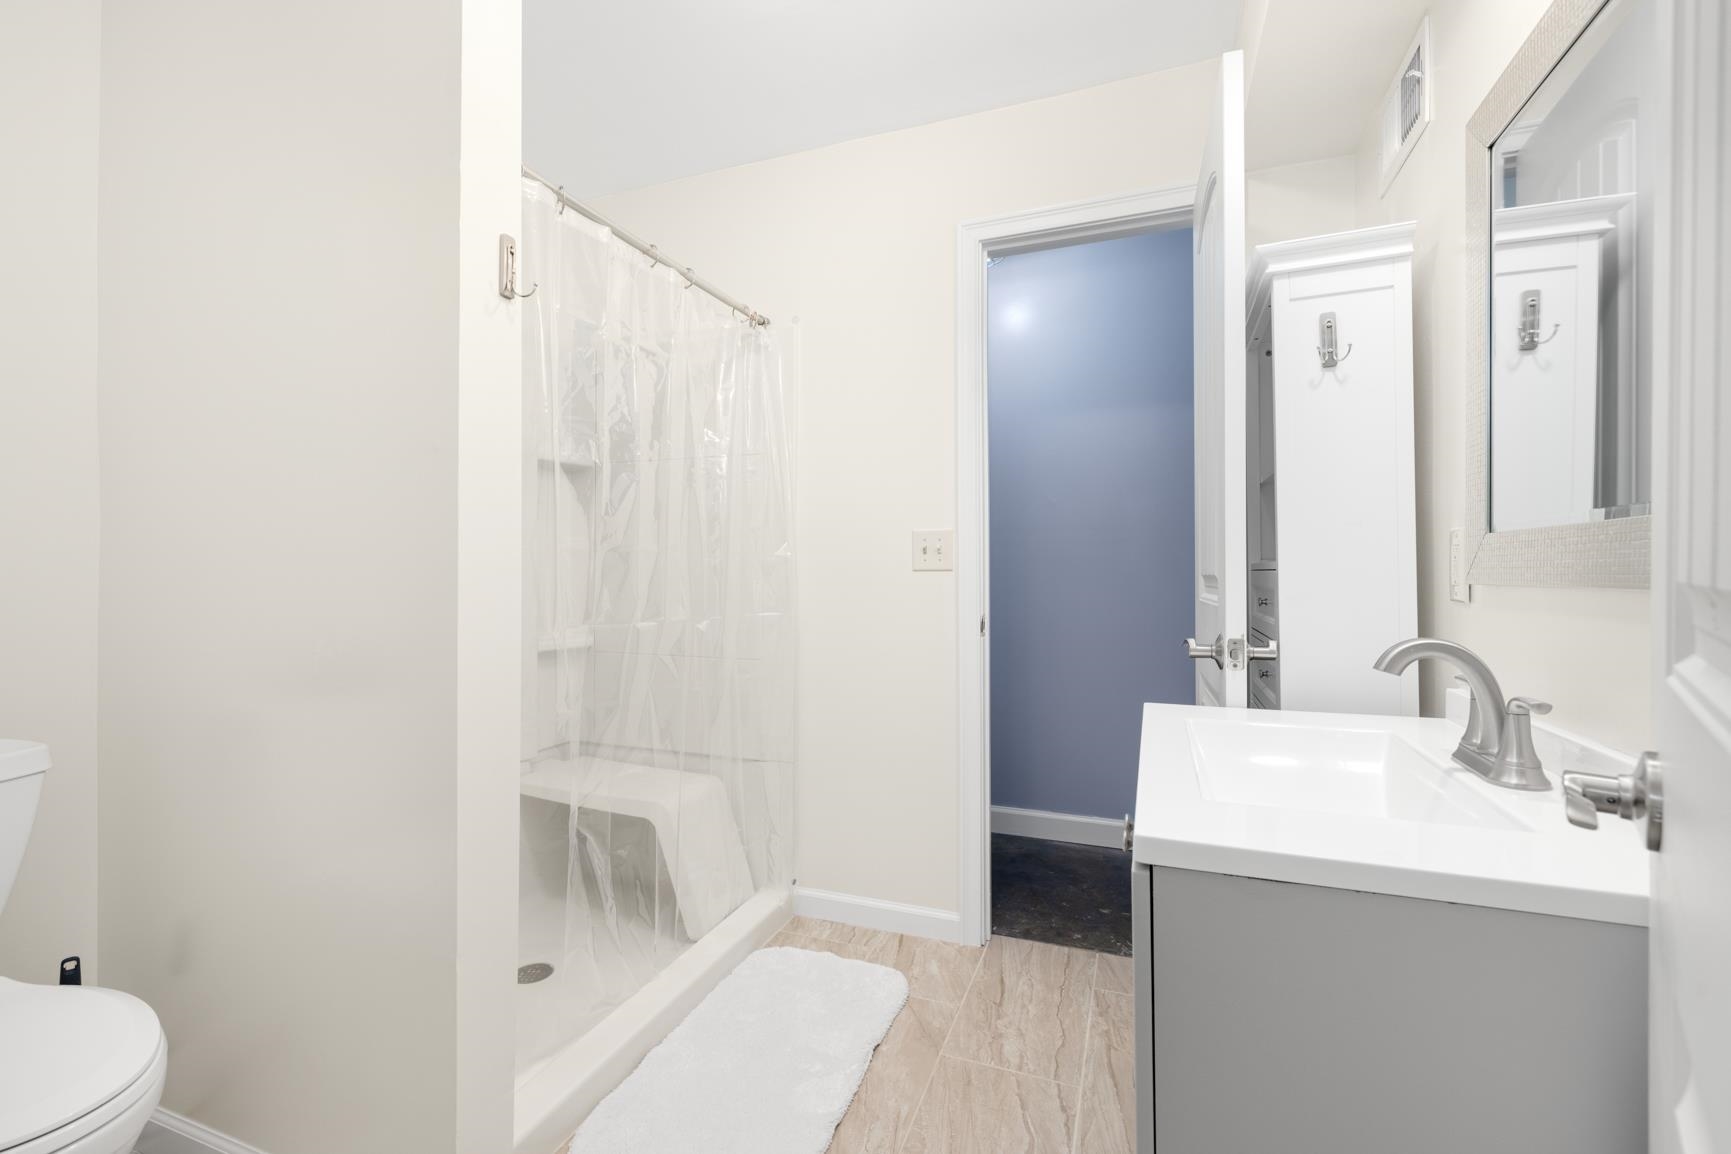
[1490,0,1655,531]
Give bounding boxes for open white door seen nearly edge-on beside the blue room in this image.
[1186,52,1248,706]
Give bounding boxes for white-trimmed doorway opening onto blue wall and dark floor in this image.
[957,189,1194,955]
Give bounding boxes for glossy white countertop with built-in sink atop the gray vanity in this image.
[1134,704,1650,926]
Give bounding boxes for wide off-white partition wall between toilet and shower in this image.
[99,0,519,1154]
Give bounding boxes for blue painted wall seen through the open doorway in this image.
[987,228,1196,818]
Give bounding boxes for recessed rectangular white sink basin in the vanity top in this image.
[1187,718,1528,830]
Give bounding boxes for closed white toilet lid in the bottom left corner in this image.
[0,978,163,1151]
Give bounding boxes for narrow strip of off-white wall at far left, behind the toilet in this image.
[0,0,100,981]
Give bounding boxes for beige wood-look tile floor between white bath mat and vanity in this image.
[769,917,1136,1154]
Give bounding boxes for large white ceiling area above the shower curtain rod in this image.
[523,0,1246,196]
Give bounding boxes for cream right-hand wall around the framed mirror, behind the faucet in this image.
[1357,0,1650,749]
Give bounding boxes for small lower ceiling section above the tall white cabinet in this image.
[1245,0,1432,170]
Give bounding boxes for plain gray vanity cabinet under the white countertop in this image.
[1132,862,1646,1154]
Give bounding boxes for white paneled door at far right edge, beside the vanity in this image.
[1648,0,1731,1154]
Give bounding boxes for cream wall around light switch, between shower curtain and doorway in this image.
[595,62,1215,910]
